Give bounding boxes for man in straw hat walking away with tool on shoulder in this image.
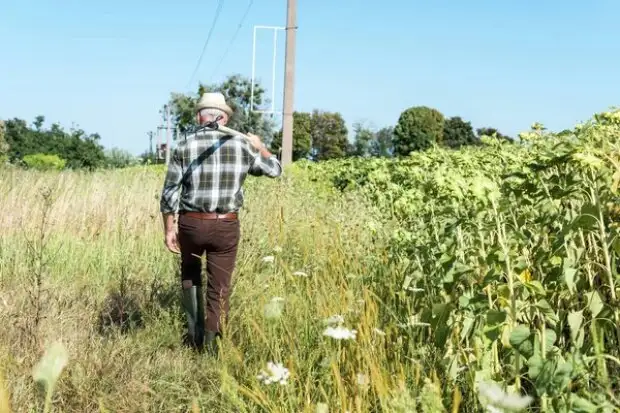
[160,93,282,353]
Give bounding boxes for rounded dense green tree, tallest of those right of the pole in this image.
[394,106,444,156]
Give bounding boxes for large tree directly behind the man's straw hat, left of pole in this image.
[169,74,275,143]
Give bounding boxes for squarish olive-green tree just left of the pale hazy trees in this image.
[310,109,348,161]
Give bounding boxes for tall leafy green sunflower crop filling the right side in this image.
[305,111,620,411]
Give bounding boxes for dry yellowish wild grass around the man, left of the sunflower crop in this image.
[0,164,436,412]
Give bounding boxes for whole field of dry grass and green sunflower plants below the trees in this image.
[0,112,620,413]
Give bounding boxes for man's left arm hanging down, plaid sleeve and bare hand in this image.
[159,149,183,252]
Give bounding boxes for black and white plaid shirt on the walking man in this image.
[160,131,282,214]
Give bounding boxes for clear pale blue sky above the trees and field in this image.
[0,0,620,154]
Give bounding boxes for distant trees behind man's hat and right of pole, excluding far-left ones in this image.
[167,74,513,161]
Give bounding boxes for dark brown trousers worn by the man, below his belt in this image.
[178,214,240,333]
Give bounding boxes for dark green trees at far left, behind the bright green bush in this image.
[5,116,105,170]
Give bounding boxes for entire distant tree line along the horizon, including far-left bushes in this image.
[0,74,513,170]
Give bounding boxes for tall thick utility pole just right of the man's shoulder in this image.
[281,0,297,167]
